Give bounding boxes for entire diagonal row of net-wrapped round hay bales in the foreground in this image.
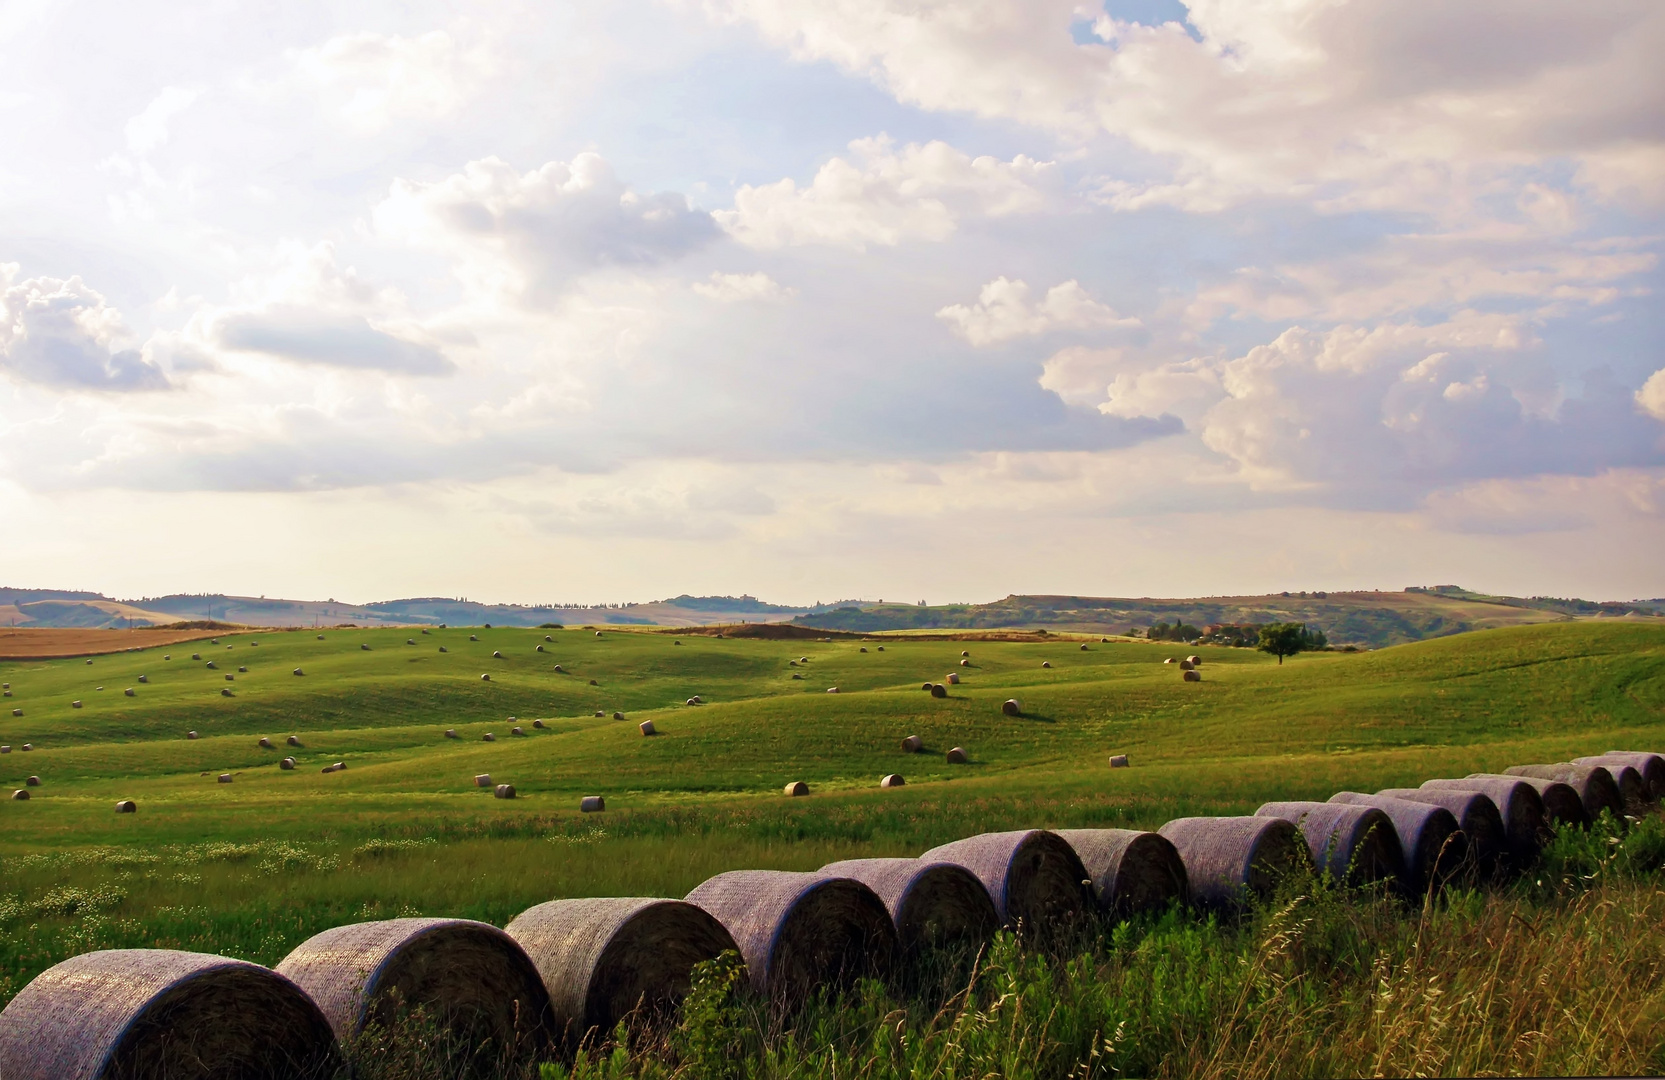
[0,752,1665,1080]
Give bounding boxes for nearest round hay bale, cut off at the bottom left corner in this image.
[0,945,340,1080]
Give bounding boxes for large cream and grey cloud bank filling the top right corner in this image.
[706,0,1665,211]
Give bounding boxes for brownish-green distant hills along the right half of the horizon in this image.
[793,586,1665,647]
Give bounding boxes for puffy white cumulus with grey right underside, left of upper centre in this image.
[373,153,719,293]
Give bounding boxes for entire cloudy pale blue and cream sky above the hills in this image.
[0,0,1665,602]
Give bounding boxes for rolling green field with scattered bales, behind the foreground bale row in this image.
[0,622,1665,1071]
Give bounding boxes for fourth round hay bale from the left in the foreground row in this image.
[688,870,896,1005]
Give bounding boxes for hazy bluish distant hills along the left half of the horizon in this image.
[0,589,816,627]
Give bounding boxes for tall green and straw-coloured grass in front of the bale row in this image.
[526,819,1665,1080]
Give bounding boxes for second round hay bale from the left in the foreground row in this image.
[276,919,549,1047]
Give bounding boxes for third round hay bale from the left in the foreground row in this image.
[503,897,739,1045]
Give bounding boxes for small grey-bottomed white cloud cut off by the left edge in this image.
[0,263,170,391]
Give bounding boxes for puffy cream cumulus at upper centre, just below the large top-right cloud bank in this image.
[713,135,1051,251]
